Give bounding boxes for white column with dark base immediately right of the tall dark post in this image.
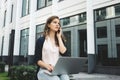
[13,0,22,64]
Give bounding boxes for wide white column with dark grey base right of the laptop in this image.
[87,0,95,73]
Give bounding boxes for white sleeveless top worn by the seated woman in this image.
[42,37,59,66]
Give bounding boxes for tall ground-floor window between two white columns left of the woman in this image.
[20,29,29,57]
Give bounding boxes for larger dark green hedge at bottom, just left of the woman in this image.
[10,65,37,80]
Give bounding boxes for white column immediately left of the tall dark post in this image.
[2,0,11,63]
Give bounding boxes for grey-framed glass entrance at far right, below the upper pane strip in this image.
[95,18,120,66]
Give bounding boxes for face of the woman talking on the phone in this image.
[48,18,60,32]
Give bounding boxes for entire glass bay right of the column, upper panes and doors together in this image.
[95,4,120,66]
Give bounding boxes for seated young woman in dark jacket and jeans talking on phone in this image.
[35,16,69,80]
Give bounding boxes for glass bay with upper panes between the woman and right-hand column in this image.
[60,12,87,57]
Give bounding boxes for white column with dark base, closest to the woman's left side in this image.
[28,0,37,64]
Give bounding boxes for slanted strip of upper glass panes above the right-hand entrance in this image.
[95,4,120,21]
